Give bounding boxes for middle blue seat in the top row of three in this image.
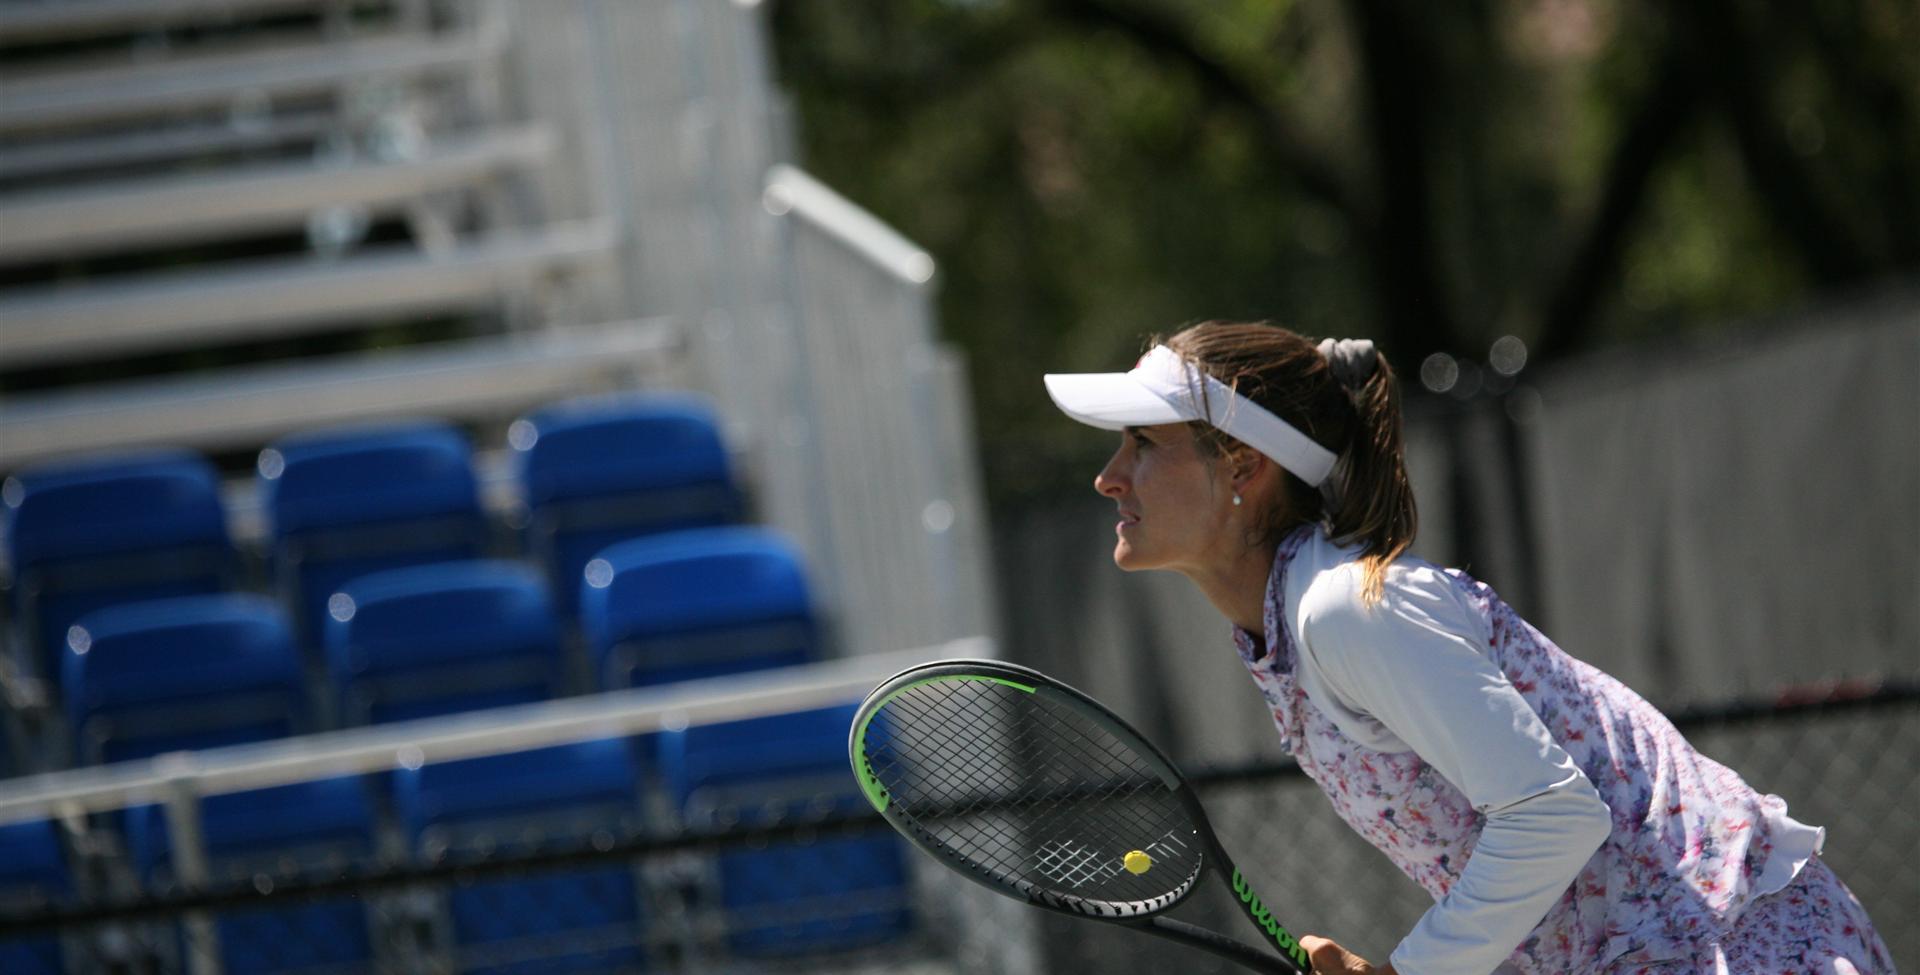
[257,420,488,649]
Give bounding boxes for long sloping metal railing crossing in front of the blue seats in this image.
[0,637,995,973]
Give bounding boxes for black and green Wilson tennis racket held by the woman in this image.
[849,660,1313,975]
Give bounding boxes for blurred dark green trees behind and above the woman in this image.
[772,0,1920,499]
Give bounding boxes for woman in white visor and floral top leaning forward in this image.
[1046,322,1893,975]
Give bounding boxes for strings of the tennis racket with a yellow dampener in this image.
[866,679,1200,912]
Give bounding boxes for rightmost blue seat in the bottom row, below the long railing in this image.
[659,704,912,958]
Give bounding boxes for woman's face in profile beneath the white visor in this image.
[1092,422,1235,572]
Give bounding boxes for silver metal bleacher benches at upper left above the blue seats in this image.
[0,0,660,468]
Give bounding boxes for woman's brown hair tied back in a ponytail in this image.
[1164,322,1419,603]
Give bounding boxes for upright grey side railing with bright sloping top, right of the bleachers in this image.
[764,167,995,664]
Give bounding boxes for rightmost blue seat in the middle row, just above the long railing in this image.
[580,526,820,687]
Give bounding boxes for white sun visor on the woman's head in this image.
[1046,345,1334,488]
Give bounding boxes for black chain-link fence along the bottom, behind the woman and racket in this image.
[0,687,1920,975]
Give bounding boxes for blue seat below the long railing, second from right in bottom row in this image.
[394,739,647,975]
